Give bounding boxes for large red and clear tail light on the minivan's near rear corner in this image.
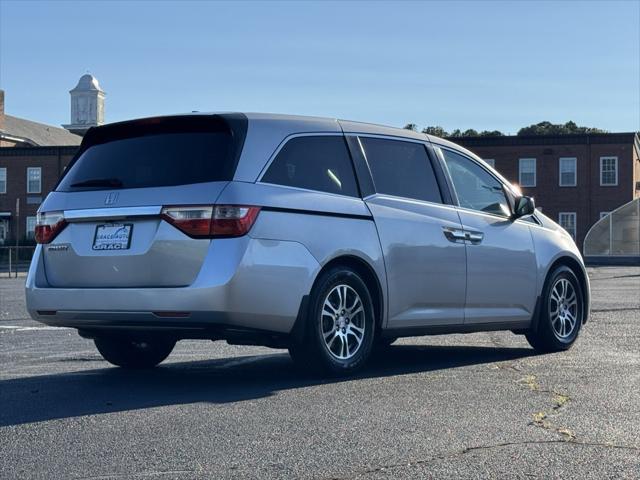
[162,205,260,238]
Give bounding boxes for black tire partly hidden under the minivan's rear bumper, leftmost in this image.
[93,335,176,369]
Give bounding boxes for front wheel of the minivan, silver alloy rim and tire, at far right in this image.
[526,266,584,352]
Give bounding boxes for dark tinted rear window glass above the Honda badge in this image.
[56,117,237,192]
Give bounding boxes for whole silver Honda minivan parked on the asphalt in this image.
[26,113,590,374]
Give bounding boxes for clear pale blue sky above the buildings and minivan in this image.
[0,0,640,134]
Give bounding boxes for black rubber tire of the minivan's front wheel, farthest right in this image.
[525,266,584,352]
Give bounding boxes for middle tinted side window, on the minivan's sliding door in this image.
[360,137,442,203]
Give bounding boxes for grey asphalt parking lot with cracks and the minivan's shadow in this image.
[0,267,640,479]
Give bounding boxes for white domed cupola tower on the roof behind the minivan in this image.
[63,73,105,135]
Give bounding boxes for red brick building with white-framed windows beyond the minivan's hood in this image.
[451,133,640,250]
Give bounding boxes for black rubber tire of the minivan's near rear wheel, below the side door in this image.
[289,266,375,375]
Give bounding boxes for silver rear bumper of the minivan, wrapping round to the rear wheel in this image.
[26,236,320,333]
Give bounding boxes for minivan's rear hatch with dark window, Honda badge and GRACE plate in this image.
[36,114,246,288]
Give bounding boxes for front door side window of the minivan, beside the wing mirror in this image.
[442,149,511,217]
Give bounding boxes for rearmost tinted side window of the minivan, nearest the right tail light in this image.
[262,135,359,197]
